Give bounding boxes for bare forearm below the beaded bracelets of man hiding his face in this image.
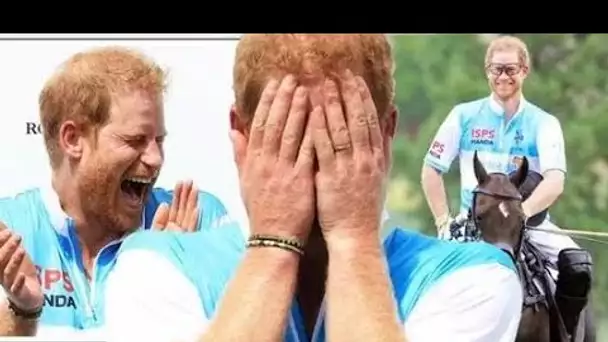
[200,248,299,342]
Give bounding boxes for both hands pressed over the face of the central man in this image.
[231,70,387,244]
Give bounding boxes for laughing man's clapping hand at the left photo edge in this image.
[0,222,44,312]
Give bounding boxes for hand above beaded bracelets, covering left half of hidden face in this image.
[231,75,315,241]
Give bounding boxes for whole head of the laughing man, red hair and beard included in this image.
[39,46,166,233]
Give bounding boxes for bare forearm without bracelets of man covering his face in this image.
[326,236,406,342]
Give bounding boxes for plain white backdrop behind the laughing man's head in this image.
[0,35,247,229]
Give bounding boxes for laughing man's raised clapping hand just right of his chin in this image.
[152,180,199,232]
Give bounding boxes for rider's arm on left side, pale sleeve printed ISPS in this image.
[421,107,461,231]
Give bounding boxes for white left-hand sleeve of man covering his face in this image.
[105,250,209,342]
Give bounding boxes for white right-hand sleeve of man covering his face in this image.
[405,264,523,342]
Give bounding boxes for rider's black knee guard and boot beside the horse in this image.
[555,248,593,336]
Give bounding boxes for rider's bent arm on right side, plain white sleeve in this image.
[522,116,566,217]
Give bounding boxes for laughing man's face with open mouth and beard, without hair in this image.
[76,91,165,232]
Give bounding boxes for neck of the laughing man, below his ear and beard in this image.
[52,175,119,270]
